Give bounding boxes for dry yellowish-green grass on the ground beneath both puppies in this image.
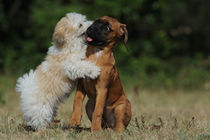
[0,75,210,140]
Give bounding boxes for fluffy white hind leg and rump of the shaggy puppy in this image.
[17,70,55,129]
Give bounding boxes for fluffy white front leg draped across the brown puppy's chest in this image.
[63,60,100,80]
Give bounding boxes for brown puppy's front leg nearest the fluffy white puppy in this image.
[70,80,85,127]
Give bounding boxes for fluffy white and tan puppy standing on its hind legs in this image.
[17,13,100,129]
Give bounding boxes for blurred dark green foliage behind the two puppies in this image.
[0,0,210,92]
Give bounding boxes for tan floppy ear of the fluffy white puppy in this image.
[52,17,68,48]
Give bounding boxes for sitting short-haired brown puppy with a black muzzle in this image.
[70,16,131,132]
